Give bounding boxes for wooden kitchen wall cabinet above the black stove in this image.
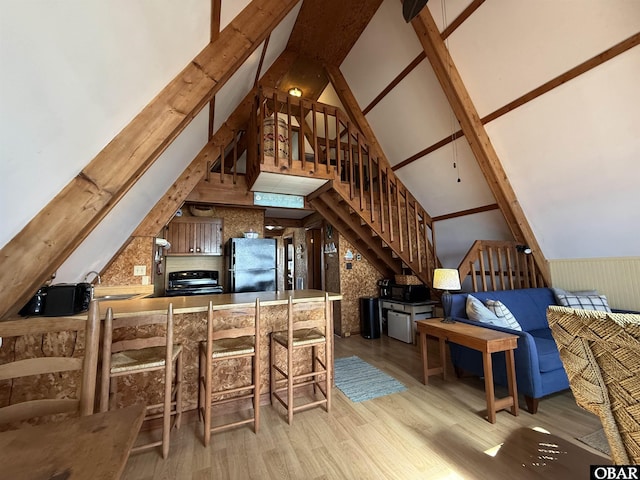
[166,217,222,255]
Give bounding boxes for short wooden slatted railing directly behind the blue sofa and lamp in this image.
[458,240,547,292]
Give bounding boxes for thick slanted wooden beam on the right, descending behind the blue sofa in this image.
[411,8,551,285]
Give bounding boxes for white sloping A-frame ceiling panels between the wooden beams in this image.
[0,0,640,288]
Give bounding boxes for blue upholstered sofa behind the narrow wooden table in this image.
[449,288,569,413]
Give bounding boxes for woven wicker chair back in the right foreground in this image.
[547,306,640,465]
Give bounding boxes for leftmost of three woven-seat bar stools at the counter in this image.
[100,304,182,458]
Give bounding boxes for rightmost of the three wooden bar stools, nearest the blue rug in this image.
[270,294,333,424]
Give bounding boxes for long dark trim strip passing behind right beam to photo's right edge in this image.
[393,33,640,171]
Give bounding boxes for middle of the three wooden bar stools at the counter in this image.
[198,299,260,446]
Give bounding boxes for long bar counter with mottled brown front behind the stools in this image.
[0,290,342,411]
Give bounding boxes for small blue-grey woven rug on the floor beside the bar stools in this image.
[334,356,406,402]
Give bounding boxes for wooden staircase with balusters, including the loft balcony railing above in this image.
[246,89,436,286]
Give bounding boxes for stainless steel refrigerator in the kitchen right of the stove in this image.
[225,238,276,293]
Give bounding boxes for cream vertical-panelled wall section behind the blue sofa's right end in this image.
[549,257,640,311]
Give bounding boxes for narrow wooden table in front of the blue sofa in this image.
[416,318,518,423]
